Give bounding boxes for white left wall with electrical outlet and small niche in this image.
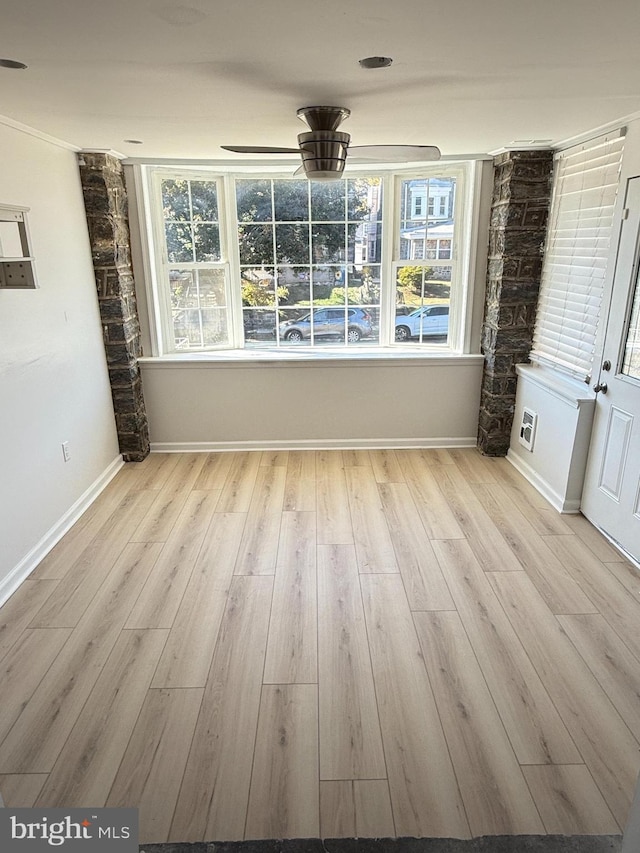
[0,123,119,603]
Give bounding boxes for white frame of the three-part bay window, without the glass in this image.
[134,161,480,360]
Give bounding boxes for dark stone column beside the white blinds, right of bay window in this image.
[478,151,553,456]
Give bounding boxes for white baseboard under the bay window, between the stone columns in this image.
[151,435,477,453]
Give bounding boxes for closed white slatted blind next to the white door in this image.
[531,132,624,381]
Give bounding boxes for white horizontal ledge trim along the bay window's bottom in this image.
[138,350,484,370]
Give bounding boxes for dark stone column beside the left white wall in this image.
[78,152,149,462]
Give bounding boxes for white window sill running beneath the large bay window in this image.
[138,347,484,368]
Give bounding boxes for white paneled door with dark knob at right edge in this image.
[582,171,640,560]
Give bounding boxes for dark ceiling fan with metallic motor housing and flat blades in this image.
[222,107,440,181]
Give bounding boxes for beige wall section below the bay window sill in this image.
[142,356,482,450]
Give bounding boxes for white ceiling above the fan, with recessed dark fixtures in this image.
[0,0,640,159]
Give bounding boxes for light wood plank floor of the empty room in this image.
[0,450,640,842]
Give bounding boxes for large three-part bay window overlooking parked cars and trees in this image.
[139,164,471,356]
